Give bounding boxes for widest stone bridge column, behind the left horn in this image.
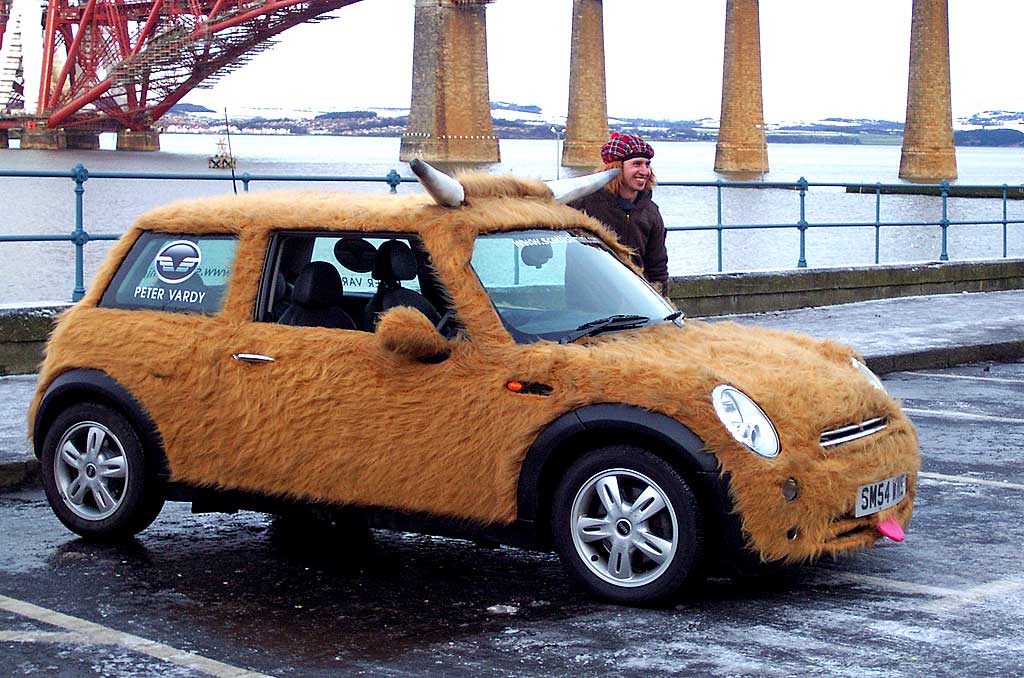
[399,0,501,163]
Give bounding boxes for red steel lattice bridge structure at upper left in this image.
[0,0,359,131]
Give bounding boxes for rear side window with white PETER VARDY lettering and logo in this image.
[99,232,238,315]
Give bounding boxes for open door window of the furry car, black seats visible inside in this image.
[257,231,454,332]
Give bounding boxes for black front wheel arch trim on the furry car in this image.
[516,402,731,543]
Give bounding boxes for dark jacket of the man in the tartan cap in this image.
[569,188,669,283]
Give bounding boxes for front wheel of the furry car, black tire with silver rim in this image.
[551,446,703,605]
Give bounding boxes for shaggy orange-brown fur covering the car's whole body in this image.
[30,177,919,560]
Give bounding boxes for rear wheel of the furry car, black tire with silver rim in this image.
[41,402,164,540]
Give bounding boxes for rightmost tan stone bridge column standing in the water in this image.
[899,0,956,181]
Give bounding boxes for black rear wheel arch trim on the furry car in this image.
[32,368,170,480]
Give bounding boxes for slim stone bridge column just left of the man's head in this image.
[562,0,608,167]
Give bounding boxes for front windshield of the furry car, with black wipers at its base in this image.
[472,229,676,343]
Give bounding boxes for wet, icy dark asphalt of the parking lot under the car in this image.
[0,362,1024,676]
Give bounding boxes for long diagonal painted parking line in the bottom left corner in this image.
[0,595,266,678]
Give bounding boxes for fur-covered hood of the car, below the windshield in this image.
[561,321,903,462]
